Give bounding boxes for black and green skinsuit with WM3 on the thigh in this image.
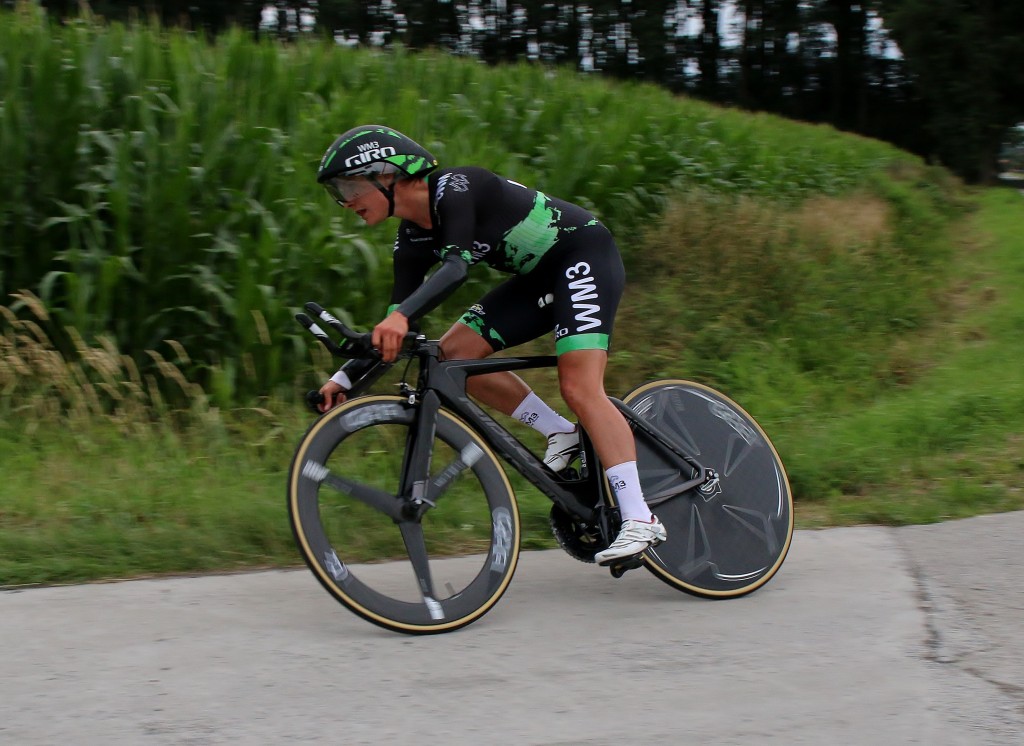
[389,167,626,354]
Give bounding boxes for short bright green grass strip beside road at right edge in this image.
[788,189,1024,523]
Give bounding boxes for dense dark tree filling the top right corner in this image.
[883,0,1024,183]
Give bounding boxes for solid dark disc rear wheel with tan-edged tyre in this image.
[624,379,794,599]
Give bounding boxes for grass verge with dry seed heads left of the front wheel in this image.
[0,288,303,586]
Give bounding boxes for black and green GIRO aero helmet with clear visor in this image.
[316,125,437,215]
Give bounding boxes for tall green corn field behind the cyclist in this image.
[0,6,911,404]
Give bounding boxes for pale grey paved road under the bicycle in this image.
[0,513,1024,746]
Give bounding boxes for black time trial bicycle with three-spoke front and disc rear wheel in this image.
[288,303,794,634]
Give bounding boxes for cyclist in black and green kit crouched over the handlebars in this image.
[316,125,667,564]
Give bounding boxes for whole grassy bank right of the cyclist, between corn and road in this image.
[610,185,1024,524]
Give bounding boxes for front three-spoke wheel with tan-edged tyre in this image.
[288,396,520,634]
